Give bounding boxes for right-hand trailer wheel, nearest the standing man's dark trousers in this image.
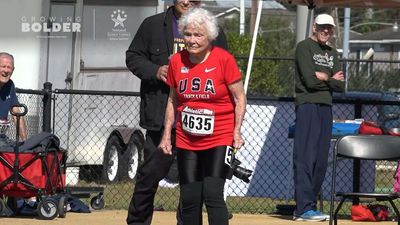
[123,133,144,180]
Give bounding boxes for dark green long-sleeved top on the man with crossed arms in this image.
[295,38,345,105]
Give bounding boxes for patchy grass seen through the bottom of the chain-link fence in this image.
[70,163,395,215]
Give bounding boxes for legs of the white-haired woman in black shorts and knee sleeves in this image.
[177,146,230,225]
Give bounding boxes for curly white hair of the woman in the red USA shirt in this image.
[178,7,218,41]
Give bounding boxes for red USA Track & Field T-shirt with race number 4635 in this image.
[167,47,241,150]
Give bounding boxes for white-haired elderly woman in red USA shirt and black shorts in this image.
[159,8,246,225]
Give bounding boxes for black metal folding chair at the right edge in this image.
[329,135,400,225]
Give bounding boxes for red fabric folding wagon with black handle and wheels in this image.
[0,105,66,219]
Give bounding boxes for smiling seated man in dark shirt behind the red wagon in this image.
[0,52,27,146]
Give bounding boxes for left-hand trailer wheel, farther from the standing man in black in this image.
[102,136,123,183]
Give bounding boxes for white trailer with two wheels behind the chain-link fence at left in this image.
[0,0,167,182]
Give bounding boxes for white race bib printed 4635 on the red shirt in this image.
[181,106,214,136]
